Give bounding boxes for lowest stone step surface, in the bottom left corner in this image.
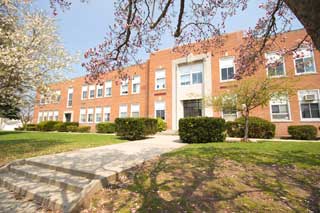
[0,187,39,213]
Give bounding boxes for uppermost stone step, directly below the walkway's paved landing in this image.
[9,164,91,193]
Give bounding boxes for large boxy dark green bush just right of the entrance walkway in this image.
[179,117,226,143]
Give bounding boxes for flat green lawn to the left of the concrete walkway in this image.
[0,131,124,166]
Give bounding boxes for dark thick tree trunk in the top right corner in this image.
[284,0,320,50]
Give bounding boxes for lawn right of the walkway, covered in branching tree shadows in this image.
[83,142,320,212]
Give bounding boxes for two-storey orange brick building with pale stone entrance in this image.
[34,30,320,136]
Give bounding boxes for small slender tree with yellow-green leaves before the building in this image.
[206,77,296,141]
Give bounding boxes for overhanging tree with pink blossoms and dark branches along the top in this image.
[46,0,320,79]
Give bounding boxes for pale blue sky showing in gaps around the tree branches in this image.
[34,0,301,77]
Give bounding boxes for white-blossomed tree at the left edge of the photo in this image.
[0,0,74,118]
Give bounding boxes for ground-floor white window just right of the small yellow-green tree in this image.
[270,96,291,121]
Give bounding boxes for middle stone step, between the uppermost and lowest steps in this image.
[0,172,80,212]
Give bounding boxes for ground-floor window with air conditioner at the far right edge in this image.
[298,90,320,121]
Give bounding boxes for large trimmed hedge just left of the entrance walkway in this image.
[115,118,157,140]
